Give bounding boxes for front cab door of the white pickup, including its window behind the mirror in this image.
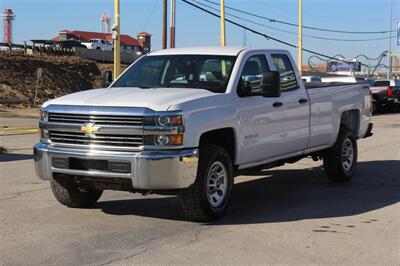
[237,54,285,165]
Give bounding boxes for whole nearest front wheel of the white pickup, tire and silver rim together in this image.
[179,145,233,222]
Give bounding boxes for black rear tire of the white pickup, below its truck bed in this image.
[323,126,357,182]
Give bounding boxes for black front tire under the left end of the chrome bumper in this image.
[50,179,103,208]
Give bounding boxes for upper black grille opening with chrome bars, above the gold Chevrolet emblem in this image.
[49,113,143,126]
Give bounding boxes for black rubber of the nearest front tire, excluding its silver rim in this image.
[179,144,233,222]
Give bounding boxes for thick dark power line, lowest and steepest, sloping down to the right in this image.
[181,0,368,67]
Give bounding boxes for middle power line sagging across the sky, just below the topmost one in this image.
[192,0,394,42]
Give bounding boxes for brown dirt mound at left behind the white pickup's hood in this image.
[0,53,107,106]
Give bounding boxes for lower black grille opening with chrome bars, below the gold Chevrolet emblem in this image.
[49,130,143,147]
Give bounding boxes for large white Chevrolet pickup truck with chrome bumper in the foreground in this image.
[34,48,372,221]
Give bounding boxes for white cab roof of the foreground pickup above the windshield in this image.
[149,46,247,56]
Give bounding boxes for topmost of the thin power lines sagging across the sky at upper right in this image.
[204,0,394,34]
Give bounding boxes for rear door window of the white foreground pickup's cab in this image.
[271,54,299,91]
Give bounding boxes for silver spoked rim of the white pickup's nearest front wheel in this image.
[207,162,228,208]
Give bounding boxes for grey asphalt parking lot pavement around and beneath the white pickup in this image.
[0,114,400,265]
